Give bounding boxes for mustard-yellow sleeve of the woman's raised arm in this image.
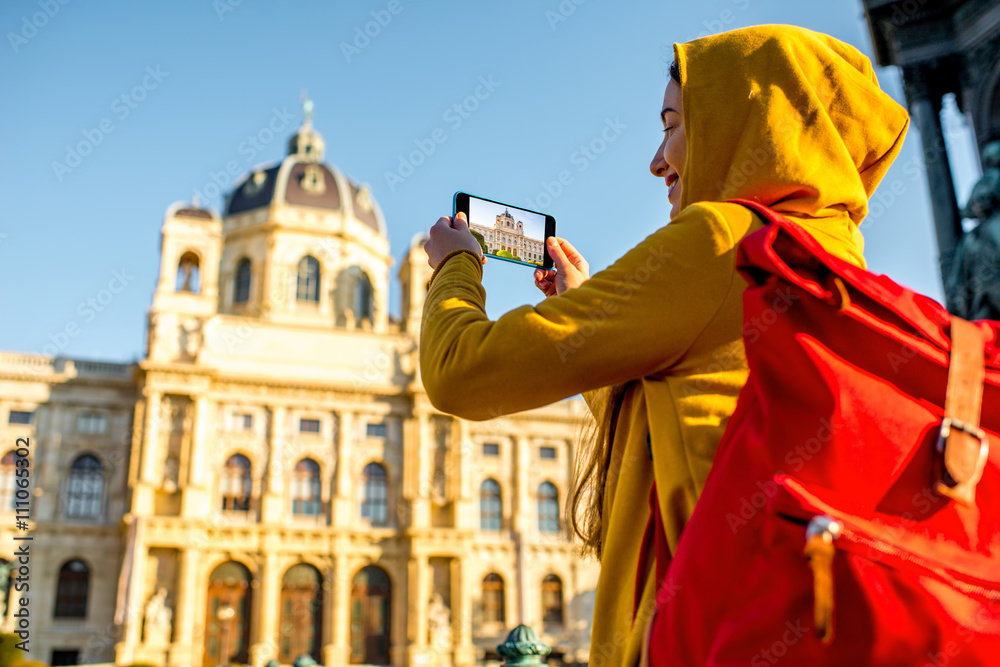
[420,204,736,420]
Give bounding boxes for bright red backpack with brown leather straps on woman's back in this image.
[645,200,1000,667]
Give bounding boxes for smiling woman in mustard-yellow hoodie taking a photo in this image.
[420,25,909,665]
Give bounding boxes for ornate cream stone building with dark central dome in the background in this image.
[0,109,598,667]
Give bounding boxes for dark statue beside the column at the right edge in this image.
[945,140,1000,320]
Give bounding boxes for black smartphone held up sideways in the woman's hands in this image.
[454,192,556,269]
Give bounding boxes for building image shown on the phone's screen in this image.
[469,197,545,266]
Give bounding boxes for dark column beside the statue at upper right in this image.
[903,66,962,288]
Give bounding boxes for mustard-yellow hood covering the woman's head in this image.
[674,25,909,267]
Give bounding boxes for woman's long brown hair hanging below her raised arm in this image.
[566,60,681,558]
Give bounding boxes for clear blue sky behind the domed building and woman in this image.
[0,0,978,360]
